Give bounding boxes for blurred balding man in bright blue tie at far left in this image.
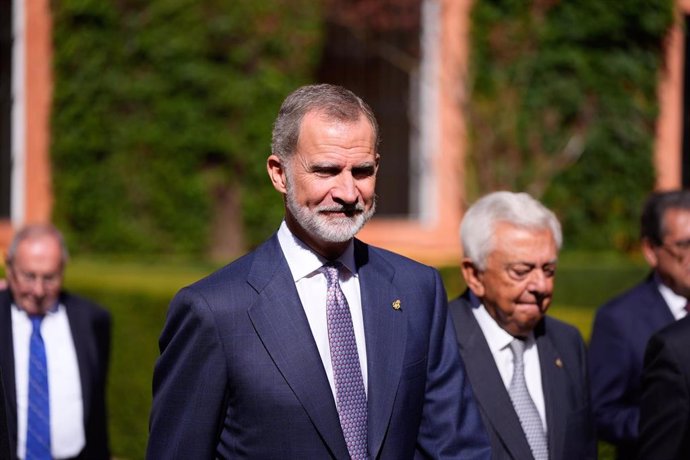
[0,225,112,460]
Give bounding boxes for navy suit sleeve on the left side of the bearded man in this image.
[146,288,228,460]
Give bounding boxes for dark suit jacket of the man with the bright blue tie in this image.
[0,290,111,460]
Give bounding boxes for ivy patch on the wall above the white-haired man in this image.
[468,0,673,250]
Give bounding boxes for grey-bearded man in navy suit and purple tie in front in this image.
[147,85,490,460]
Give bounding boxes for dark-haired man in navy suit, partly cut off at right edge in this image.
[589,190,690,460]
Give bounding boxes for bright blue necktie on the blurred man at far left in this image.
[26,315,51,460]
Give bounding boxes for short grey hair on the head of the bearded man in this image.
[271,83,379,160]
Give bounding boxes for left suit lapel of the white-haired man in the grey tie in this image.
[451,296,532,459]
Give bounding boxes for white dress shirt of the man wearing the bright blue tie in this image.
[12,305,86,459]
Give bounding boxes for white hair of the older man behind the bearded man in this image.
[460,191,563,270]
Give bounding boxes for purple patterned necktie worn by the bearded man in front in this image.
[324,262,368,460]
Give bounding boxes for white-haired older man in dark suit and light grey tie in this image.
[449,192,597,460]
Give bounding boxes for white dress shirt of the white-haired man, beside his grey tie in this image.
[472,305,547,432]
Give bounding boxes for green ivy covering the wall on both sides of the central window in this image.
[51,0,673,254]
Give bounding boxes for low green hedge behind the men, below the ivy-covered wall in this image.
[60,253,648,460]
